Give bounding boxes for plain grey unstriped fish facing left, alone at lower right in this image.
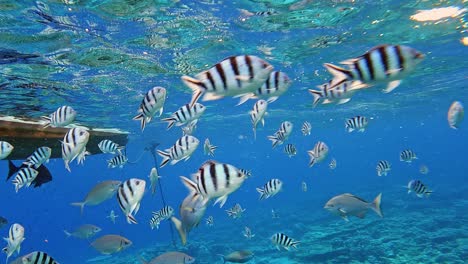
[324,193,383,221]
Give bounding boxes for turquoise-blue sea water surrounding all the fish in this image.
[0,0,468,264]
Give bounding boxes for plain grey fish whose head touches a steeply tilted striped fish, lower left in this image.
[71,181,122,214]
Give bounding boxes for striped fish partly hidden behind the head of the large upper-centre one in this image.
[237,71,291,105]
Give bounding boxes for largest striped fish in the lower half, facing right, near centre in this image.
[181,160,246,207]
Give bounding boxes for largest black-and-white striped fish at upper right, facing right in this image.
[324,45,424,93]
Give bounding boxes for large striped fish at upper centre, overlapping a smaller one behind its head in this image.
[182,55,273,106]
